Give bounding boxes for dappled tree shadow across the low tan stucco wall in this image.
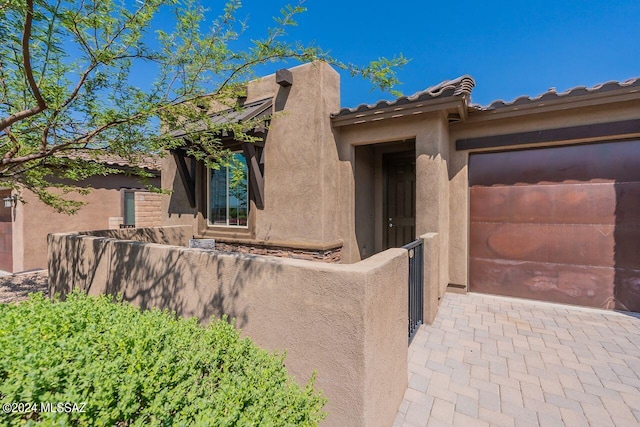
[49,231,282,327]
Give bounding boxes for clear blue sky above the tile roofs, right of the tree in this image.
[232,0,640,107]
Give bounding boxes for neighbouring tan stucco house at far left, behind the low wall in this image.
[0,156,162,273]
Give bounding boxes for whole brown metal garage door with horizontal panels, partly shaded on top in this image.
[469,141,640,311]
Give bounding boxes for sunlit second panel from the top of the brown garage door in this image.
[470,183,620,224]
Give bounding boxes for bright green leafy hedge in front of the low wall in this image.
[0,293,325,426]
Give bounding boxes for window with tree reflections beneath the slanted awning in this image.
[207,153,249,227]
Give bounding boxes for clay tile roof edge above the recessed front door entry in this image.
[332,75,476,117]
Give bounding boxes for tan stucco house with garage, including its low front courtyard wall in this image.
[49,62,640,426]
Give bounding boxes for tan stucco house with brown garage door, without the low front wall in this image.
[162,63,640,311]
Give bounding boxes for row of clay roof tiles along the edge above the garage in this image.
[474,77,640,110]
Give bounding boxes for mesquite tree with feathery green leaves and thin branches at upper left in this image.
[0,0,406,212]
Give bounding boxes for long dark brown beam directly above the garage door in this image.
[456,119,640,150]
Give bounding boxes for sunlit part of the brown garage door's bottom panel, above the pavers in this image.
[469,257,615,308]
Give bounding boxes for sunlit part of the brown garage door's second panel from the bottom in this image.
[469,223,615,267]
